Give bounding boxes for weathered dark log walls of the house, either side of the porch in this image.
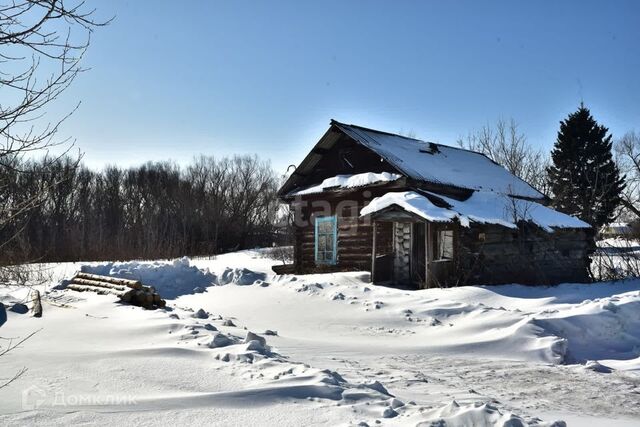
[294,189,593,286]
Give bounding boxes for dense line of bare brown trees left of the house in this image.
[0,156,279,263]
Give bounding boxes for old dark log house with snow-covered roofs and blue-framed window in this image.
[277,121,594,288]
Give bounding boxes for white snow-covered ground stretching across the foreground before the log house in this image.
[0,251,640,426]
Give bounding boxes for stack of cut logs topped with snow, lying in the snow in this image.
[67,272,166,309]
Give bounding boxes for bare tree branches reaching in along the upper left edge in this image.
[0,0,108,281]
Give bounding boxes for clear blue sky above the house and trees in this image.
[52,0,640,172]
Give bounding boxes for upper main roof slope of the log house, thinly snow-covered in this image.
[332,121,544,199]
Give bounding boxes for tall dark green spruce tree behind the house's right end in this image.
[548,103,624,230]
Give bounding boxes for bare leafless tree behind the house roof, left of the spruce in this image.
[458,119,549,195]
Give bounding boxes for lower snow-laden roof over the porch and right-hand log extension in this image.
[360,191,591,231]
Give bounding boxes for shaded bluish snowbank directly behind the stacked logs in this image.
[80,257,217,299]
